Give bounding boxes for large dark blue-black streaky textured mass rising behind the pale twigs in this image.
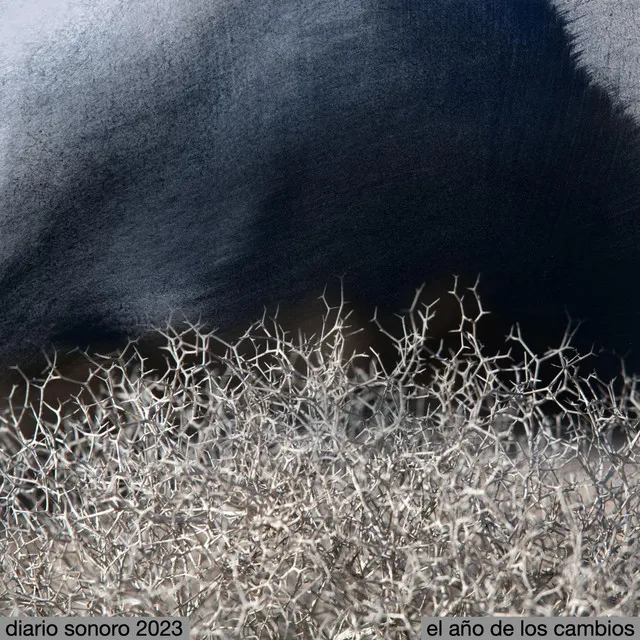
[0,0,640,372]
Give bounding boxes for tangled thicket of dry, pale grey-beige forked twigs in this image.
[0,292,640,640]
